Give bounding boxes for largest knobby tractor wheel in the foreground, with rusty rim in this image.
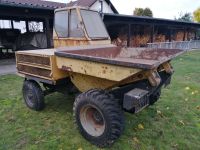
[73,89,124,147]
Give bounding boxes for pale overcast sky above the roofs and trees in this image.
[49,0,200,19]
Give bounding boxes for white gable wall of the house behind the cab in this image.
[90,0,114,13]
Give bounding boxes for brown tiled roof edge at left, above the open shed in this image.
[0,0,66,10]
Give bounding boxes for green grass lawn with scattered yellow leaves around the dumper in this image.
[0,51,200,150]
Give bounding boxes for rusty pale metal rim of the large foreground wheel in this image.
[80,105,105,137]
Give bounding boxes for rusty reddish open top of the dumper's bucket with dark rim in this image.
[55,45,184,70]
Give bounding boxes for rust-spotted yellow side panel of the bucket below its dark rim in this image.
[56,57,141,82]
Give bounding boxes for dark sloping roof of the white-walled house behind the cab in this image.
[67,0,118,14]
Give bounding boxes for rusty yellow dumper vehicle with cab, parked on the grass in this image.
[16,7,183,147]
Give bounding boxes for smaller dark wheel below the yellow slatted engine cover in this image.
[22,80,45,111]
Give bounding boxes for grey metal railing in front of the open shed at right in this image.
[147,40,200,51]
